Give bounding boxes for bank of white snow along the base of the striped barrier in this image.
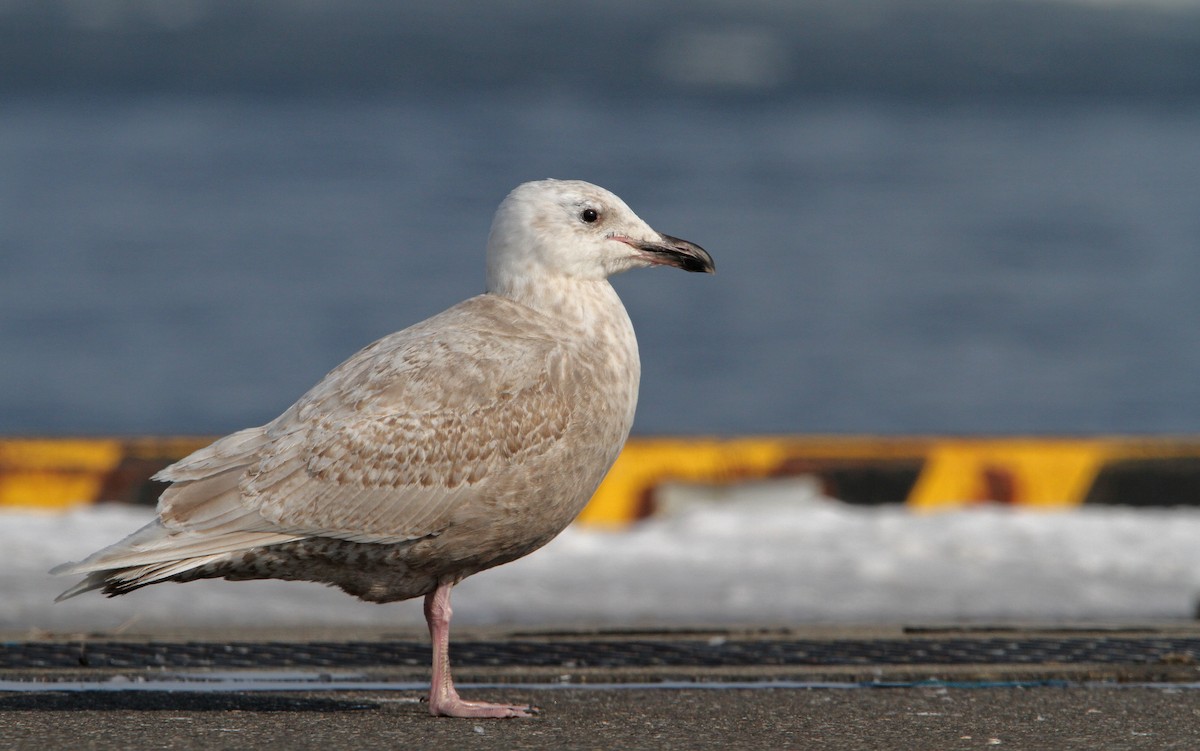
[9,480,1200,631]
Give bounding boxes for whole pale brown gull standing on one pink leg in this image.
[53,180,713,717]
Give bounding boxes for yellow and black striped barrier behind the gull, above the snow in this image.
[7,435,1200,525]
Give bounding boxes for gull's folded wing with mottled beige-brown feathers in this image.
[160,295,577,547]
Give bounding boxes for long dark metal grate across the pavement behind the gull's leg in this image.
[0,637,1200,669]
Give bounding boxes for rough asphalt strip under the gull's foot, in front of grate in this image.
[7,687,1200,751]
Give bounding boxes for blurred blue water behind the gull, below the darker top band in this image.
[0,4,1200,434]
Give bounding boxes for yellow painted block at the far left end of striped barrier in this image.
[0,438,122,509]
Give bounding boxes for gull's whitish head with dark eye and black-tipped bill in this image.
[487,180,714,292]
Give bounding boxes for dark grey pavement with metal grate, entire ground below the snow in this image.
[0,624,1200,751]
